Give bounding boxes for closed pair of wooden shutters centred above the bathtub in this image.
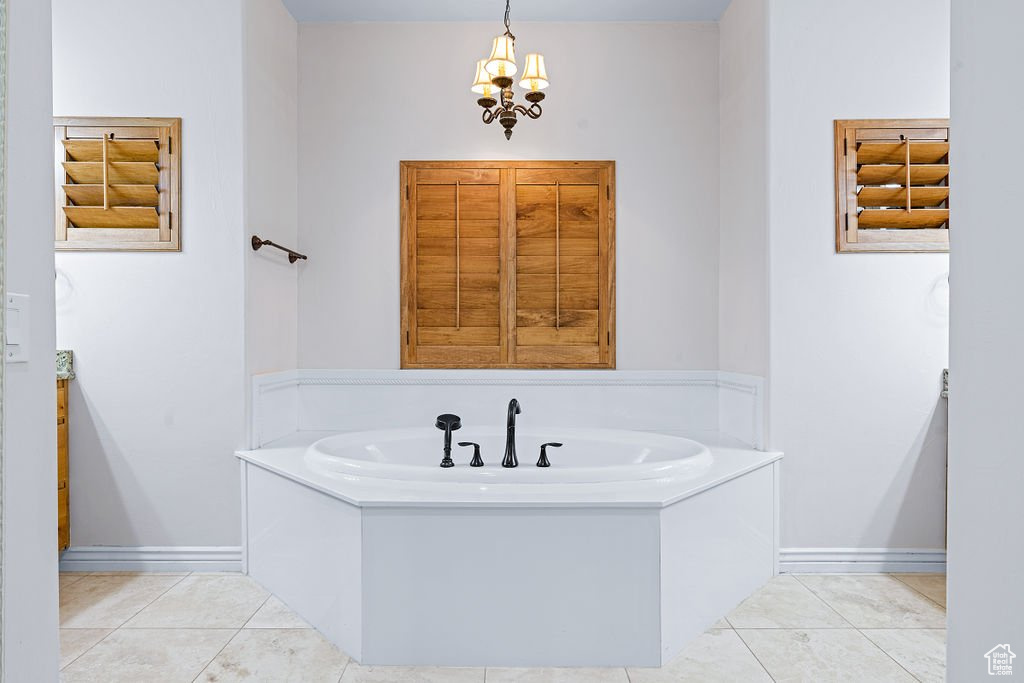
[401,161,615,368]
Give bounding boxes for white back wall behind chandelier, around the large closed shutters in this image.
[299,23,719,369]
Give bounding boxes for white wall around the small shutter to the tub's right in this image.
[768,0,950,548]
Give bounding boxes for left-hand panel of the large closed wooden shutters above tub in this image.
[402,167,508,368]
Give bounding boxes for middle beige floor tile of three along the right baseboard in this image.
[798,574,946,629]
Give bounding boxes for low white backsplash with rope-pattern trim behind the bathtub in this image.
[249,370,764,449]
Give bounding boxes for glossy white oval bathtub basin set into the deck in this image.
[305,427,714,486]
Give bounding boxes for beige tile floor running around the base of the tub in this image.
[60,572,946,683]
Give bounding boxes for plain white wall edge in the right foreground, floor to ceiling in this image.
[947,0,1024,681]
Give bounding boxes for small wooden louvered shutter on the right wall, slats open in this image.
[836,119,949,252]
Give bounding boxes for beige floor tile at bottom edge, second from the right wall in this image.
[736,629,914,683]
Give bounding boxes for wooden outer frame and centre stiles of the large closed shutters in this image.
[399,161,615,370]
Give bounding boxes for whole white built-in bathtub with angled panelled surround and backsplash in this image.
[239,372,781,667]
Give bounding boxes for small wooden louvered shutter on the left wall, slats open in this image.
[53,118,181,251]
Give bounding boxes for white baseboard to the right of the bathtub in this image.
[778,548,946,573]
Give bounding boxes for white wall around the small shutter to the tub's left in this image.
[53,0,247,546]
